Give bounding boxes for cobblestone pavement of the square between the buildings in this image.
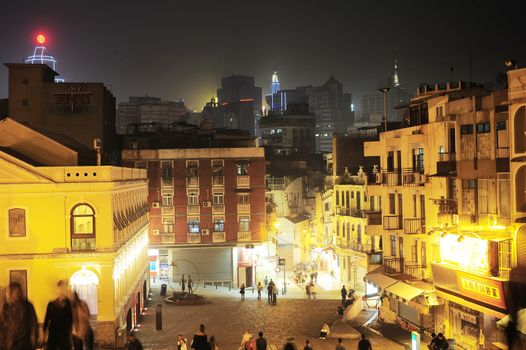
[137,286,403,350]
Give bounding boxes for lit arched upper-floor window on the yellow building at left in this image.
[71,204,95,250]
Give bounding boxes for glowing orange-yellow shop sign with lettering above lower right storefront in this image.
[457,271,506,309]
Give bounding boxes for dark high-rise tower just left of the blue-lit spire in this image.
[215,74,262,135]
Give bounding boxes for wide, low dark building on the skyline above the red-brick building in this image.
[117,96,188,134]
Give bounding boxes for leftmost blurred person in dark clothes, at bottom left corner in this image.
[0,282,38,350]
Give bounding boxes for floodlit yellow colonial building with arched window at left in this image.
[0,119,149,347]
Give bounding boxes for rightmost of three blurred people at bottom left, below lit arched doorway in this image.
[71,291,93,350]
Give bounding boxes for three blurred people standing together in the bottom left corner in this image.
[0,280,93,350]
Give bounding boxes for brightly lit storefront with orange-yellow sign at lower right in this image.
[432,264,508,350]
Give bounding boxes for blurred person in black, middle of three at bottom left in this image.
[43,280,73,350]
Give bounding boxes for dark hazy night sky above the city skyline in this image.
[0,0,526,110]
